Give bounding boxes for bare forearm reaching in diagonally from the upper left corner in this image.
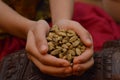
[0,1,34,38]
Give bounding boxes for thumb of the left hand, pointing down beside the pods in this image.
[33,20,50,54]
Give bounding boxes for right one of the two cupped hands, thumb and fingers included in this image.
[56,20,94,75]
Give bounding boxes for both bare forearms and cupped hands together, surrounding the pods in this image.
[0,0,94,77]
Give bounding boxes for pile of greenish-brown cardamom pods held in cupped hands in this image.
[47,25,86,63]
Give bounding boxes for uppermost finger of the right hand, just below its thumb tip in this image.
[73,47,93,64]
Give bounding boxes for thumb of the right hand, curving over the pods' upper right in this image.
[57,20,93,46]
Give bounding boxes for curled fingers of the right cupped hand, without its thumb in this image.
[73,46,94,75]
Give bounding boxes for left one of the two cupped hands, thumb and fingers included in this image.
[26,20,72,77]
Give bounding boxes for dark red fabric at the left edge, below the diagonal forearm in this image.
[0,36,25,60]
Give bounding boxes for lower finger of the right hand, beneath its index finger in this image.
[73,58,94,72]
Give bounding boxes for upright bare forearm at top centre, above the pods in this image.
[50,0,74,24]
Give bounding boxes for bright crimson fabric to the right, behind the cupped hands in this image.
[73,2,120,51]
